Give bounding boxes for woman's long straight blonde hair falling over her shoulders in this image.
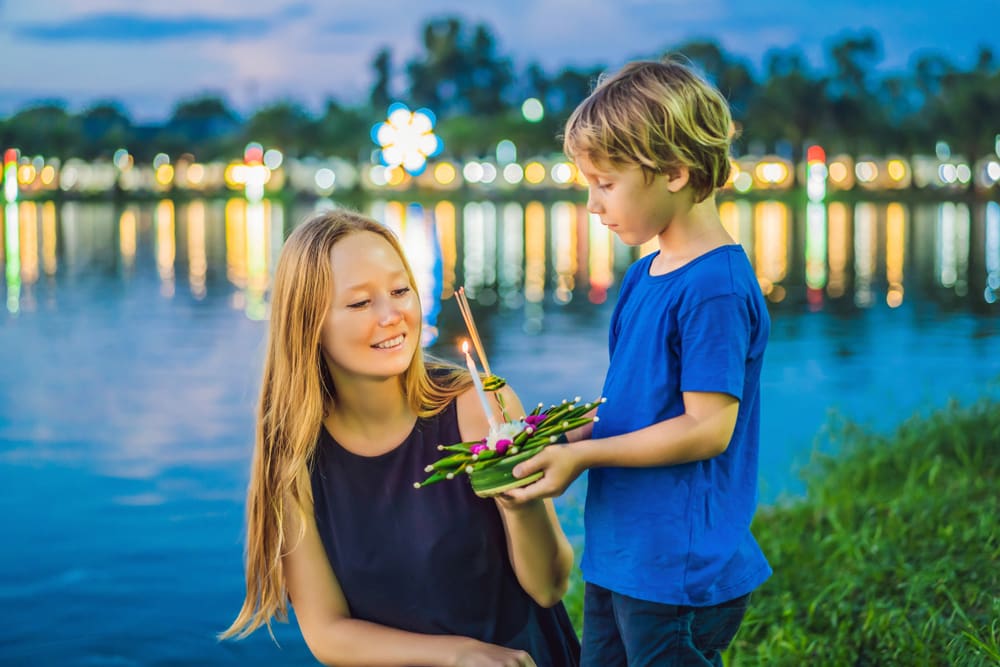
[219,210,471,639]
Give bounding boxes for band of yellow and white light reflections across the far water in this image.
[0,198,1000,320]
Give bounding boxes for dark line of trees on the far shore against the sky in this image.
[0,18,1000,160]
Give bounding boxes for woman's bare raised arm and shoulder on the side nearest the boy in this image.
[457,386,573,607]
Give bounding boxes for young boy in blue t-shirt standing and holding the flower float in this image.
[508,61,771,667]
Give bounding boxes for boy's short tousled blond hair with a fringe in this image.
[563,58,733,201]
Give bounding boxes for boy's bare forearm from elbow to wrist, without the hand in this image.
[567,403,739,468]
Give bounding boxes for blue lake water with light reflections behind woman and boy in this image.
[0,199,1000,666]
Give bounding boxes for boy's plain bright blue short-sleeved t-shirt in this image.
[581,245,771,606]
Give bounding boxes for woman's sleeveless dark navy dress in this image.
[311,401,580,667]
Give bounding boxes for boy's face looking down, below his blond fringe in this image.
[576,155,687,245]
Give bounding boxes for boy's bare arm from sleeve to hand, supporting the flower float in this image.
[507,391,740,502]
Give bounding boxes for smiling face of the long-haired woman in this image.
[320,232,420,382]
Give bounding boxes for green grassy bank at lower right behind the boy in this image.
[568,399,1000,667]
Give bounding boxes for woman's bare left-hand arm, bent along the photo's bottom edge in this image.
[282,490,535,667]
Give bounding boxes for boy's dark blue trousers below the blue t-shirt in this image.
[581,583,750,667]
